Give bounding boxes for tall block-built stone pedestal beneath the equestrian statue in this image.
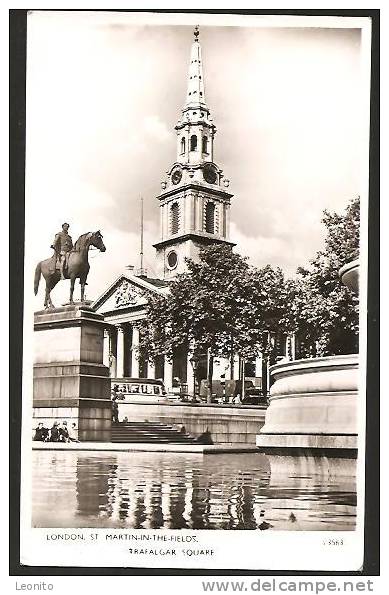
[33,303,111,442]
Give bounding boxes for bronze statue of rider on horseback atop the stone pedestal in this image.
[34,223,105,308]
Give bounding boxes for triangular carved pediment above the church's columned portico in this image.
[92,275,166,314]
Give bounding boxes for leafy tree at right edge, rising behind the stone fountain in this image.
[289,197,360,357]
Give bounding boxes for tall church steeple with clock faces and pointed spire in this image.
[154,27,235,280]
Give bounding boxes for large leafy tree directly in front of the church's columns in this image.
[139,245,289,397]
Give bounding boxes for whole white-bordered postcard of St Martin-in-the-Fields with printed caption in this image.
[15,10,371,571]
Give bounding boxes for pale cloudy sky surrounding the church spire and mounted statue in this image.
[26,11,368,309]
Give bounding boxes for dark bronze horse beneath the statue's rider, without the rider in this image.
[34,231,105,308]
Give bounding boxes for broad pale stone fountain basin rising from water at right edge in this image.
[256,354,358,450]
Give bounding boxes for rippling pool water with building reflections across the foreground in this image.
[32,451,356,530]
